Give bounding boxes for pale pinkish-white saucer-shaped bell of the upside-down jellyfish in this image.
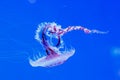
[29,49,75,67]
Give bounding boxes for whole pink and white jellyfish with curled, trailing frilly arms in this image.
[29,22,107,67]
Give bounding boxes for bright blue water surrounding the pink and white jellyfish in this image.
[0,0,120,80]
